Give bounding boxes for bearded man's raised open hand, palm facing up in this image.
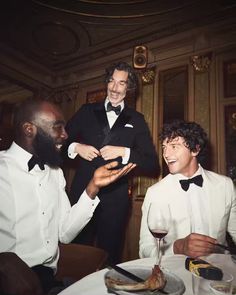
[86,161,136,199]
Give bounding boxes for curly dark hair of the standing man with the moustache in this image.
[105,61,138,90]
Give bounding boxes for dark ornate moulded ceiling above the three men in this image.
[0,0,235,93]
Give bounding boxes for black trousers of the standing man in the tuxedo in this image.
[73,193,129,264]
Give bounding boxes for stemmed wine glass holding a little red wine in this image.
[147,202,171,266]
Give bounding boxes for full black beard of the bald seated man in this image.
[33,127,62,168]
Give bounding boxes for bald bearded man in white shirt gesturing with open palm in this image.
[0,100,135,295]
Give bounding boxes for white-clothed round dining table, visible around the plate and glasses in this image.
[59,254,236,295]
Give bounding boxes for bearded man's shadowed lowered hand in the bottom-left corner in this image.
[0,252,43,295]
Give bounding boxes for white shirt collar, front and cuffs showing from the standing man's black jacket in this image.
[67,98,130,164]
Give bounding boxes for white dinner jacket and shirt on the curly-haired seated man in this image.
[139,165,225,258]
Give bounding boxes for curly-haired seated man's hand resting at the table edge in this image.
[174,233,216,258]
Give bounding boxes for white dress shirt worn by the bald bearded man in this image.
[0,142,99,268]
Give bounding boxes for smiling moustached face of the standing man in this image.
[107,70,128,106]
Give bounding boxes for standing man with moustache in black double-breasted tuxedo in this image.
[66,62,159,263]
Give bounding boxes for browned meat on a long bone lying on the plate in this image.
[105,265,166,291]
